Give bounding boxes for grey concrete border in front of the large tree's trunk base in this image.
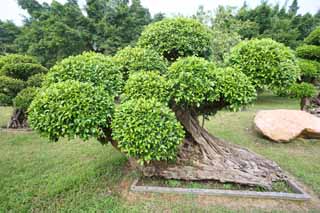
[130,178,311,201]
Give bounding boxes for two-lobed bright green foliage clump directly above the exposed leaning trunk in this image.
[166,56,256,111]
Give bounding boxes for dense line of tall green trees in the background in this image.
[0,0,320,67]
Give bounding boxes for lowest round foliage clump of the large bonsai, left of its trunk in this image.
[112,98,184,163]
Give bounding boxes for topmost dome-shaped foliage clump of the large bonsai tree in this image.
[137,18,212,61]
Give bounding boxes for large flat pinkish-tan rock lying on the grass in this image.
[254,109,320,142]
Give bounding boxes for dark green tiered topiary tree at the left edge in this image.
[0,54,48,128]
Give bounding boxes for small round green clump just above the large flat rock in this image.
[289,82,317,98]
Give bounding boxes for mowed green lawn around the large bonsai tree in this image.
[0,94,320,212]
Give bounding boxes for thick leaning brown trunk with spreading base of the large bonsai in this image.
[143,109,286,189]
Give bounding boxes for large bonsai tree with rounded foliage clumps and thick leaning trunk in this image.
[29,18,298,188]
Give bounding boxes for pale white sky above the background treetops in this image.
[0,0,320,25]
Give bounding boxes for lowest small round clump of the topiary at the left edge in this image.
[13,87,38,111]
